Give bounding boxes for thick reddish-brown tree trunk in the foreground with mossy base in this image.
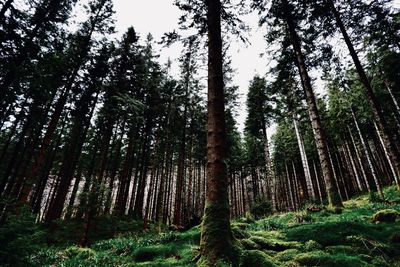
[200,0,235,266]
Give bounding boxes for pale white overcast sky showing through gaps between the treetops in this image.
[109,0,400,133]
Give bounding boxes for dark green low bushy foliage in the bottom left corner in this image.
[0,208,44,266]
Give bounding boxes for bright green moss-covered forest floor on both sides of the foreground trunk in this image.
[3,187,400,267]
